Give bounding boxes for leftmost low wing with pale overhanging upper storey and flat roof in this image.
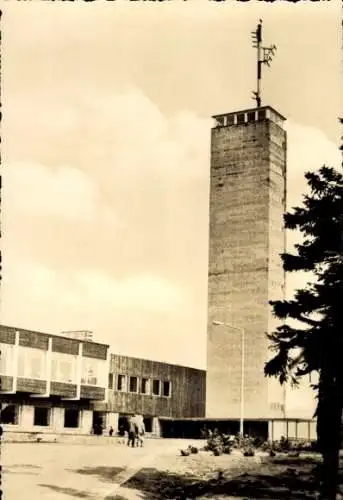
[0,325,109,434]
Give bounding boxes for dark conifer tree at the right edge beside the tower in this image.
[265,138,343,500]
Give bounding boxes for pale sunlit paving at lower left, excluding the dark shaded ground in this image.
[1,438,199,500]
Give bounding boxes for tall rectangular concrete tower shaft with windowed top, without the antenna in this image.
[206,106,287,420]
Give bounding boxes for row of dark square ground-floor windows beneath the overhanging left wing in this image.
[1,404,80,429]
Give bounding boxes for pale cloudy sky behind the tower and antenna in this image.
[1,0,341,374]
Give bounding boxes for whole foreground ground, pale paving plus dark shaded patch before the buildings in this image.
[1,437,330,500]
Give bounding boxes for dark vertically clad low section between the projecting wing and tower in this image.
[96,354,206,435]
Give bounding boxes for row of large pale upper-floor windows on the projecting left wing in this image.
[0,344,107,387]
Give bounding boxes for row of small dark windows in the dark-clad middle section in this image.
[108,373,171,398]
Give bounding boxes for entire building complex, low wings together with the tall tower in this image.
[0,107,315,439]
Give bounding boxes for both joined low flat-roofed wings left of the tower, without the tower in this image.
[0,326,205,436]
